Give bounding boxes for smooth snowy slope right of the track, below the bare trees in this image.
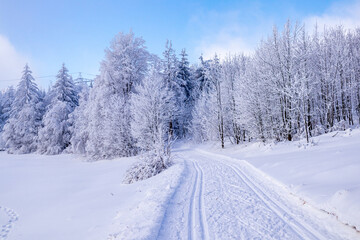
[193,129,360,235]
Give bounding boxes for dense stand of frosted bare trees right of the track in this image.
[192,22,360,143]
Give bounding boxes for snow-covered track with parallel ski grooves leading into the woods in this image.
[158,149,356,239]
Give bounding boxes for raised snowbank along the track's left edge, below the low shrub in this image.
[108,163,184,240]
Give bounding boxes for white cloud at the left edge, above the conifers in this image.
[0,35,27,90]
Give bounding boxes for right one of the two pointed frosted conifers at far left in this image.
[38,64,78,154]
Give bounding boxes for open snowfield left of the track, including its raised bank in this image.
[0,152,182,240]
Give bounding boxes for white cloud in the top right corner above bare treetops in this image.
[304,0,360,30]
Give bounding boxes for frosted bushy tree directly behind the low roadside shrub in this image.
[131,65,177,151]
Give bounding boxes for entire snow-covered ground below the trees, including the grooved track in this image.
[0,129,360,240]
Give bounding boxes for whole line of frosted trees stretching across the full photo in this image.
[0,22,360,161]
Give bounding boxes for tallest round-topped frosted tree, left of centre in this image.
[82,32,149,159]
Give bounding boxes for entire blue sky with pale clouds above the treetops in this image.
[0,0,360,89]
